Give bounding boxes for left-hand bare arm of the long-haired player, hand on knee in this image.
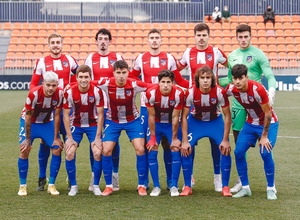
[181,107,192,157]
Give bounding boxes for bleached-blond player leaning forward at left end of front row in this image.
[18,71,63,196]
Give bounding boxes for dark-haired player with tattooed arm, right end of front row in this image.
[227,64,279,200]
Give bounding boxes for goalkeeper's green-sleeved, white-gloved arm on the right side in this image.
[259,52,276,106]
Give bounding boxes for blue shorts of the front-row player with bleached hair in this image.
[19,118,59,149]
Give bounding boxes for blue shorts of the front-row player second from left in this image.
[71,126,97,146]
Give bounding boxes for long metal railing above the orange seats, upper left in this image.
[0,1,204,23]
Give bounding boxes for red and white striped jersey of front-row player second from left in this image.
[64,84,104,127]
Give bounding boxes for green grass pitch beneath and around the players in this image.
[0,91,300,219]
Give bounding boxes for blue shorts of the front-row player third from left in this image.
[102,118,145,142]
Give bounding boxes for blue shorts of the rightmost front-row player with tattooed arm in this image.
[236,122,279,148]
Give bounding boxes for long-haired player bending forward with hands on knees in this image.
[180,66,232,196]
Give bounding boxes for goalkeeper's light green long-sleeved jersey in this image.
[219,45,276,109]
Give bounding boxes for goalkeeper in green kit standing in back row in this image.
[220,24,276,192]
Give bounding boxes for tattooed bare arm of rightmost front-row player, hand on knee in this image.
[259,103,272,153]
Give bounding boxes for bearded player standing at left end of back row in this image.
[30,33,78,191]
